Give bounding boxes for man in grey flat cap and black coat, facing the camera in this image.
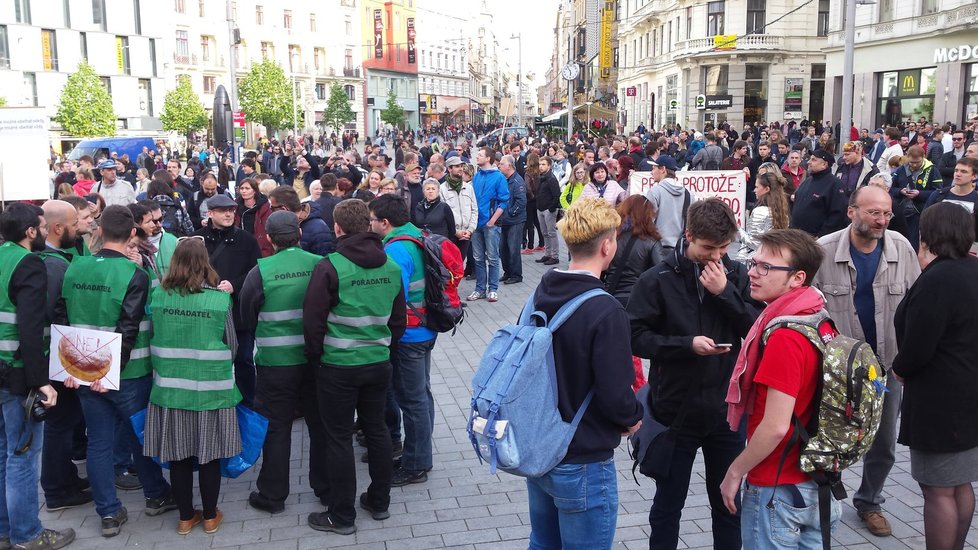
[193,194,261,407]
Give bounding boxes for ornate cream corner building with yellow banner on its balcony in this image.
[618,0,824,130]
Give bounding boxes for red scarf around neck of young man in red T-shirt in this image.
[726,286,825,432]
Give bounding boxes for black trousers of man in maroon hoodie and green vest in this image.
[316,363,394,525]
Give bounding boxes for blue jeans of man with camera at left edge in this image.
[0,389,44,544]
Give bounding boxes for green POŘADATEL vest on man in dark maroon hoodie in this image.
[320,252,401,367]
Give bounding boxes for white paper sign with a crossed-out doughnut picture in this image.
[48,325,122,390]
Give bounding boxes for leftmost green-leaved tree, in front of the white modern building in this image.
[54,61,115,137]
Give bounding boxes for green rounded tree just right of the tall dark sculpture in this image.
[238,59,303,133]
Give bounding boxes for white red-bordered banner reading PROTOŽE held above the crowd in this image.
[628,170,747,227]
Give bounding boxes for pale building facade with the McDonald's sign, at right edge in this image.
[826,0,978,129]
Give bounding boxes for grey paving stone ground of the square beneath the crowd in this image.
[41,253,978,550]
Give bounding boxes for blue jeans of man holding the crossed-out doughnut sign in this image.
[77,375,170,517]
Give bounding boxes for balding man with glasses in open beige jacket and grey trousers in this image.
[812,187,920,537]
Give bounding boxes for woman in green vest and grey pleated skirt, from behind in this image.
[143,236,241,535]
